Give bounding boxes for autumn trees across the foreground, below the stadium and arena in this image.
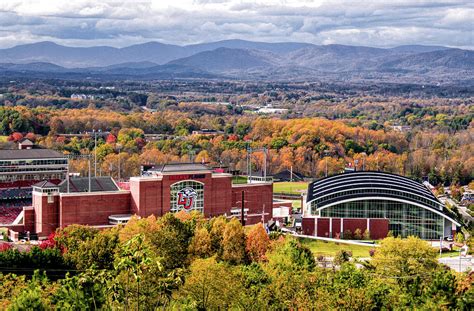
[0,212,474,310]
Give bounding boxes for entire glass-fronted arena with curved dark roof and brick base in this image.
[303,171,460,240]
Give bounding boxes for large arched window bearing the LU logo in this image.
[170,180,204,213]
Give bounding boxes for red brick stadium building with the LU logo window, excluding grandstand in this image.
[9,163,273,238]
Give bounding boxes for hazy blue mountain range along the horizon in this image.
[0,40,474,83]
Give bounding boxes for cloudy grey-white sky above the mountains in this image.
[0,0,474,49]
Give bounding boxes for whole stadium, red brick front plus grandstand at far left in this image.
[0,148,273,240]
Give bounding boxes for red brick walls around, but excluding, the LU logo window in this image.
[11,172,273,238]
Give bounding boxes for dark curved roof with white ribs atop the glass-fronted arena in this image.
[307,171,443,210]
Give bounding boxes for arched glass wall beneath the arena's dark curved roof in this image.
[311,200,444,240]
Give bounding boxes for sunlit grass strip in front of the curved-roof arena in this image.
[299,238,375,257]
